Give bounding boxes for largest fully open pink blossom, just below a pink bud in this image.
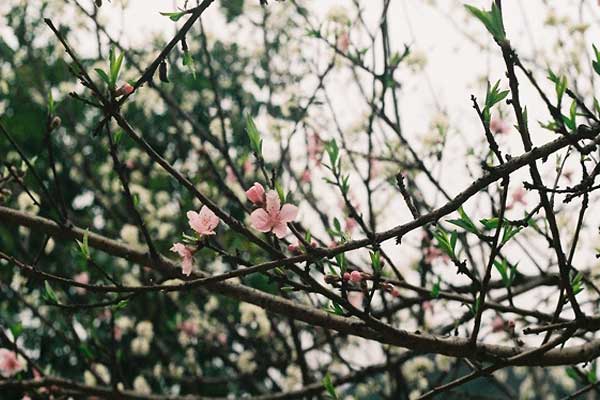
[250,190,298,239]
